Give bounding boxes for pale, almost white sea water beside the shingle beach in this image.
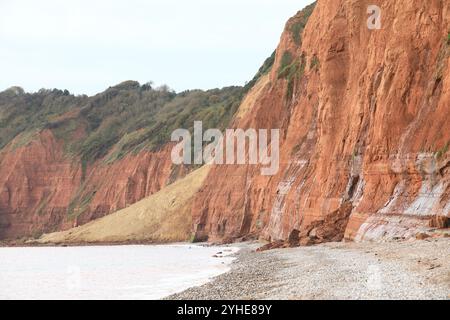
[0,244,236,299]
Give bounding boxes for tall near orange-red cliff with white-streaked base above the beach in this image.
[192,0,450,245]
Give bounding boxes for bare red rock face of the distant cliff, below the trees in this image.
[0,130,178,239]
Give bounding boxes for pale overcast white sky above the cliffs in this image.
[0,0,313,95]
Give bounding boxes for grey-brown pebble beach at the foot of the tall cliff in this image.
[164,238,450,300]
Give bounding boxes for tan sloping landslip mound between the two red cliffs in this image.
[38,166,209,243]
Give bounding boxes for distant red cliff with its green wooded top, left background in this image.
[0,82,242,239]
